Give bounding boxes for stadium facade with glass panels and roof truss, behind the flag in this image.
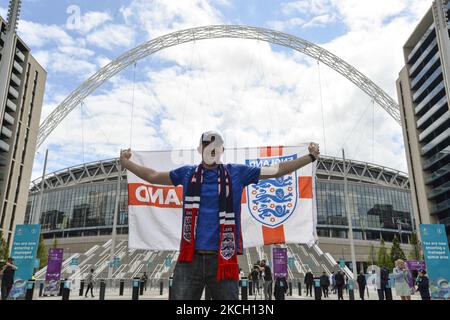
[25,156,415,268]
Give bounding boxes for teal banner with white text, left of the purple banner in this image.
[9,224,41,299]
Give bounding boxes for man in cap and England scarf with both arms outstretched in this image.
[120,131,320,300]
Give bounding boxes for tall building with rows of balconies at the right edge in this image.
[397,0,450,240]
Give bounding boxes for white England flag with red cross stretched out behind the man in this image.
[127,144,317,250]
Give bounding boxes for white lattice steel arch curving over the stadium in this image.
[37,25,400,147]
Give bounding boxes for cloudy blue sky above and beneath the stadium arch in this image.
[0,0,432,179]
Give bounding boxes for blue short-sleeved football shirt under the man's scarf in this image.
[170,164,261,250]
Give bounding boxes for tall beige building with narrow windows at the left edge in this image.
[0,6,47,248]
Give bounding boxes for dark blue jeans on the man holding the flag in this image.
[172,252,239,300]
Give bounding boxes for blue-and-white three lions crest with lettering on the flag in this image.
[246,154,298,228]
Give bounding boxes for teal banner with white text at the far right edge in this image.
[419,224,450,299]
